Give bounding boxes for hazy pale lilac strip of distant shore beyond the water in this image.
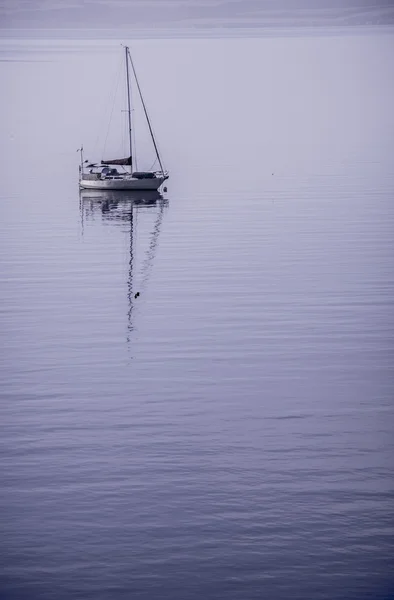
[0,0,394,31]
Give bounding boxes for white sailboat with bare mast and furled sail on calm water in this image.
[79,46,169,191]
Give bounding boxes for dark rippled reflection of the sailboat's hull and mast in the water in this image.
[80,190,168,342]
